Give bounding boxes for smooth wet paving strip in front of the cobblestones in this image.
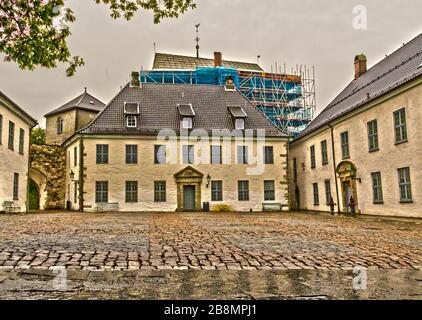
[0,269,422,300]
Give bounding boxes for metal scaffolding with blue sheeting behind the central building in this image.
[140,65,316,136]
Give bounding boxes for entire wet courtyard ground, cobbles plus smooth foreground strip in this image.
[0,213,422,299]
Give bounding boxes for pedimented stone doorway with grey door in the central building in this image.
[174,166,204,211]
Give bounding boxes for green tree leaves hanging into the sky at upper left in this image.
[0,0,196,77]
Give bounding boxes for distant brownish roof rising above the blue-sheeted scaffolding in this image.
[152,53,264,72]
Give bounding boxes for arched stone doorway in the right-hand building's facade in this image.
[336,161,359,213]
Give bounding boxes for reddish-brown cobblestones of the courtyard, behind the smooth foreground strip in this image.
[0,213,422,271]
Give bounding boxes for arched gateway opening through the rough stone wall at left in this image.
[29,168,48,210]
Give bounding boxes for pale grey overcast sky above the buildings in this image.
[0,0,422,124]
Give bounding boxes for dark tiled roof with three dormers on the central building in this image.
[79,83,288,137]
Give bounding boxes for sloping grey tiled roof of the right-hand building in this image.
[297,34,422,139]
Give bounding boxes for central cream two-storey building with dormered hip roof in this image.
[64,76,289,212]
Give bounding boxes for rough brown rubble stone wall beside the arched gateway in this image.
[30,145,66,210]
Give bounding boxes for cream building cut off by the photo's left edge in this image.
[0,92,37,212]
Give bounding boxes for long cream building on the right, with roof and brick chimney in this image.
[289,34,422,218]
